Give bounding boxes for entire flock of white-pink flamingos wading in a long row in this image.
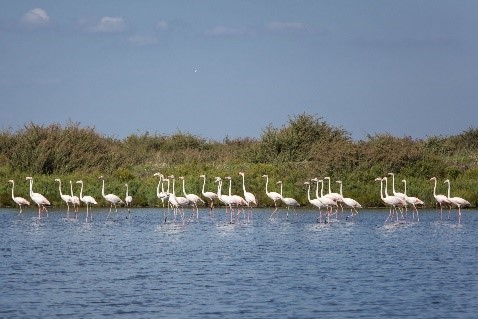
[8,172,470,224]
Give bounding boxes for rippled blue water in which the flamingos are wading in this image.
[0,208,478,318]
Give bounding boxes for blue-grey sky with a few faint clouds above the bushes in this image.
[0,0,478,141]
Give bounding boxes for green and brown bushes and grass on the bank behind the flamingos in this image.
[0,113,478,210]
